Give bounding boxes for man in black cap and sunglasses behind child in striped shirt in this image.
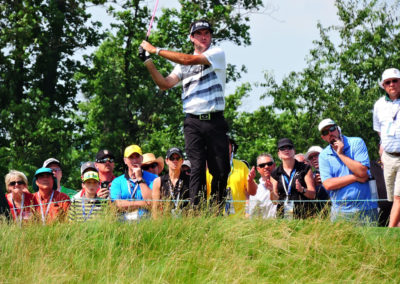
[95,149,115,198]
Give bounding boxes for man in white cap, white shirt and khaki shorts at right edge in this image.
[373,68,400,227]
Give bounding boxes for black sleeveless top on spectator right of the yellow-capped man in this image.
[160,172,190,208]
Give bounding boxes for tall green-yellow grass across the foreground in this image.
[0,216,400,283]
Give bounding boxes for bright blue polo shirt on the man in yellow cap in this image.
[110,171,157,216]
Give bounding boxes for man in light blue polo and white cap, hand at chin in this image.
[318,118,378,223]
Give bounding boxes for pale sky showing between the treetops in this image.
[88,0,338,111]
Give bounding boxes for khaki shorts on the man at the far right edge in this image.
[381,151,400,201]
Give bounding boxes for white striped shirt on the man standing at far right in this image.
[374,96,400,153]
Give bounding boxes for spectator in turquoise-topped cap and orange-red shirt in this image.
[32,168,70,224]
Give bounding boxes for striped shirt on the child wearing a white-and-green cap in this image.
[68,195,107,222]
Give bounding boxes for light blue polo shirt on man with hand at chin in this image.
[319,136,378,213]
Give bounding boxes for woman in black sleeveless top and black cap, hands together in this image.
[271,138,315,218]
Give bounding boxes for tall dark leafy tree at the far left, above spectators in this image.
[0,0,102,185]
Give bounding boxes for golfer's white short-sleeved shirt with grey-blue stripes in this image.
[172,47,226,115]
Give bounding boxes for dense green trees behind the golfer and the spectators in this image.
[0,0,400,191]
